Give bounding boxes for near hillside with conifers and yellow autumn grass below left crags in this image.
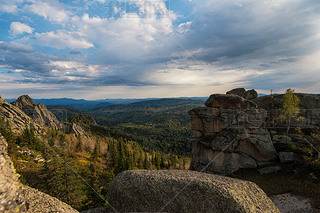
[0,116,190,210]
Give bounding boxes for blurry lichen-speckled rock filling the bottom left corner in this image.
[0,135,78,213]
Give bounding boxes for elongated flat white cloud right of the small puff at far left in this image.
[35,31,94,49]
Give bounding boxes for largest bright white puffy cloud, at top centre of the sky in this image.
[72,1,176,63]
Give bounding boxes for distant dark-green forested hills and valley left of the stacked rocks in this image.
[49,99,203,156]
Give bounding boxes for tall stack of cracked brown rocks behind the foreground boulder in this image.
[189,90,277,174]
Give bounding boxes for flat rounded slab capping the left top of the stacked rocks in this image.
[204,94,257,109]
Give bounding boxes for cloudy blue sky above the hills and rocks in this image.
[0,0,320,100]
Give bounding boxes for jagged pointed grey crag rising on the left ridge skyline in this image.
[11,95,60,129]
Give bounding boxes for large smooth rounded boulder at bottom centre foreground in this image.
[109,170,279,213]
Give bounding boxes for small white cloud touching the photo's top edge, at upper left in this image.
[24,0,71,23]
